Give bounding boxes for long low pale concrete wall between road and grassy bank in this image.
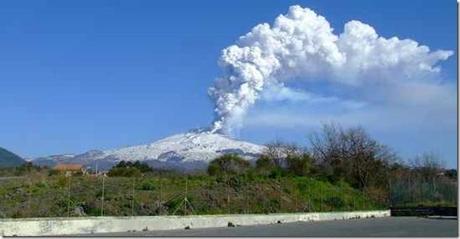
[0,210,390,236]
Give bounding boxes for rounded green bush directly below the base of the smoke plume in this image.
[208,154,251,176]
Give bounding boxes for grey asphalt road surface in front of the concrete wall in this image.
[86,217,458,237]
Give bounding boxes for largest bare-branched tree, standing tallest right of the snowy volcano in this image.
[310,124,396,189]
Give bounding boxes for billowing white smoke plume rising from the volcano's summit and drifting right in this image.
[209,6,453,133]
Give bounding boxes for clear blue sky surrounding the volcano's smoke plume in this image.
[0,0,457,167]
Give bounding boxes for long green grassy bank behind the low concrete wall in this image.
[0,176,382,217]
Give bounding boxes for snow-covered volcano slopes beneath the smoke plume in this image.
[33,131,264,170]
